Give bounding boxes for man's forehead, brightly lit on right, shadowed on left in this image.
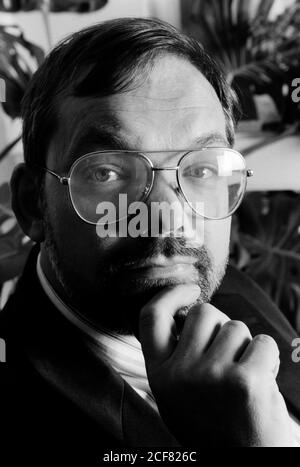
[49,56,226,166]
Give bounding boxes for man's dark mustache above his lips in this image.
[107,237,212,274]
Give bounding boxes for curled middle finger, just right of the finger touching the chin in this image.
[176,303,229,360]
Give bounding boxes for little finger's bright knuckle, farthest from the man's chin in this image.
[239,334,280,376]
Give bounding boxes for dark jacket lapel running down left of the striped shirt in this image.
[3,248,176,446]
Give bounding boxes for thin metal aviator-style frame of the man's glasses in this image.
[40,146,254,225]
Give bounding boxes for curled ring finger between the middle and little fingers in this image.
[206,321,252,366]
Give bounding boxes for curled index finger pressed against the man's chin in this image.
[140,284,200,368]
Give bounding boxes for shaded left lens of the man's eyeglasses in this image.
[70,152,152,224]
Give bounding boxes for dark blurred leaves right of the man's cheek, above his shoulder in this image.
[231,192,300,331]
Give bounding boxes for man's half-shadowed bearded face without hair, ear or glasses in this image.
[42,56,230,332]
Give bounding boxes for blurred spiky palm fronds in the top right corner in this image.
[187,0,300,123]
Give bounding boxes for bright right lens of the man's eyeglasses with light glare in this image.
[178,148,247,219]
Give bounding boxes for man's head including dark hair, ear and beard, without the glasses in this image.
[12,18,243,332]
